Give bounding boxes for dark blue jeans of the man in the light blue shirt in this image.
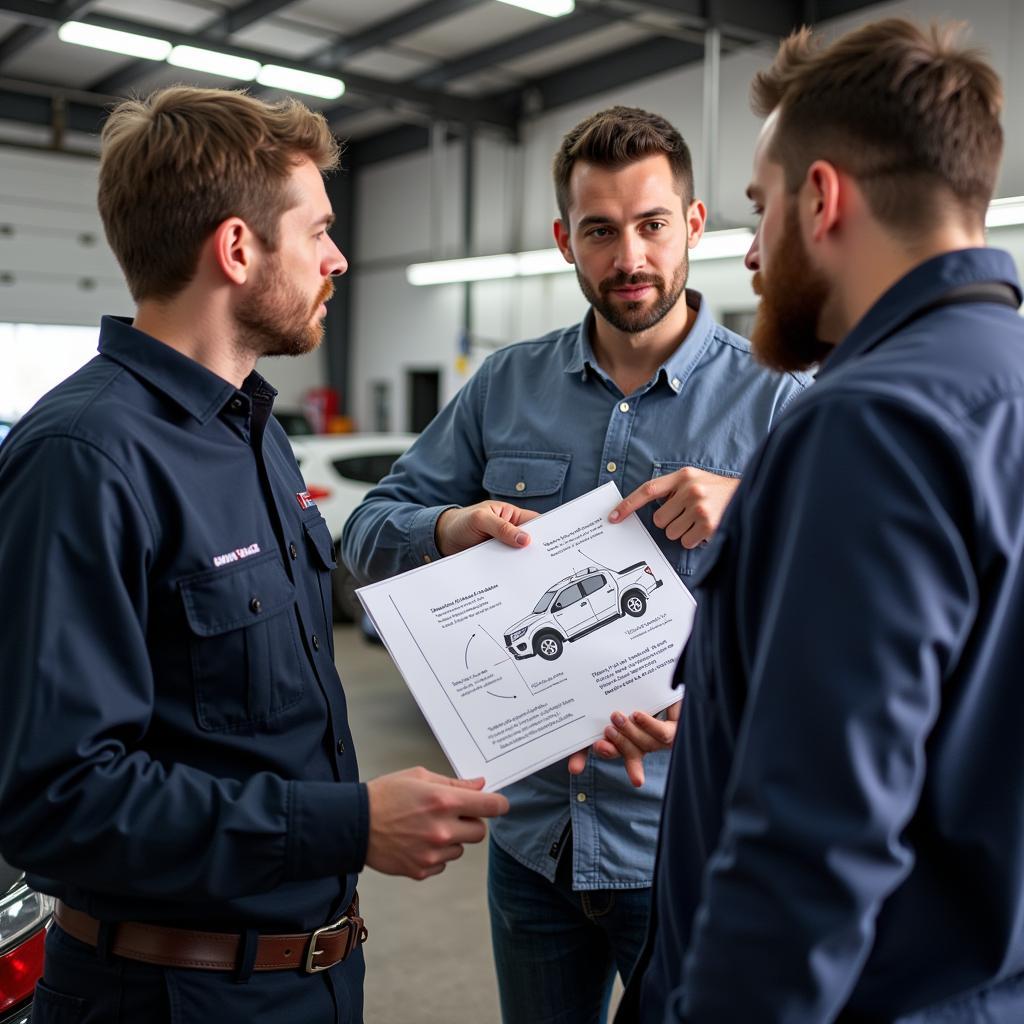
[487,841,650,1024]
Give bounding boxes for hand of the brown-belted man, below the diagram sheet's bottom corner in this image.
[367,768,509,879]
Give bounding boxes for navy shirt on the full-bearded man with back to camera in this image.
[620,249,1024,1024]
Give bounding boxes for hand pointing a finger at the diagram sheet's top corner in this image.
[608,466,739,548]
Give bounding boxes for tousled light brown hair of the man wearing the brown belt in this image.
[99,86,340,302]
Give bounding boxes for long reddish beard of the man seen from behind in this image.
[751,200,833,373]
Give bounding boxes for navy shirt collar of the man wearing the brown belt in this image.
[99,316,278,425]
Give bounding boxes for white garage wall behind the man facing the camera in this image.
[350,0,1024,429]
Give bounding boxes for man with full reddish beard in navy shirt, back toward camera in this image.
[618,19,1024,1024]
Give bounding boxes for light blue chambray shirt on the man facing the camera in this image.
[342,291,810,889]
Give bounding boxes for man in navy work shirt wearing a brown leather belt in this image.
[0,88,507,1024]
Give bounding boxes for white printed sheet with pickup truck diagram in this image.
[357,483,696,790]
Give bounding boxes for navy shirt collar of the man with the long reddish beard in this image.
[816,249,1021,380]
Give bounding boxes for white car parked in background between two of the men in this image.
[289,434,416,622]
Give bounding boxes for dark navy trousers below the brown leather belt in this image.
[32,924,364,1024]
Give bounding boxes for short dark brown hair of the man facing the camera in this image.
[554,106,693,220]
